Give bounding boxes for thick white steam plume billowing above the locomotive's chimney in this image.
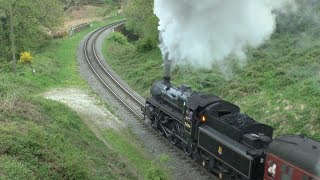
[154,0,291,68]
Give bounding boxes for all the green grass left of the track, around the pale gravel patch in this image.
[0,18,169,179]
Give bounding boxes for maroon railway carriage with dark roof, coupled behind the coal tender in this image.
[264,135,320,180]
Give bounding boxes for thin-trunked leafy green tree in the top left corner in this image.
[0,0,63,73]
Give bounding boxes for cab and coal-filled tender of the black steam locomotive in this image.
[187,93,273,179]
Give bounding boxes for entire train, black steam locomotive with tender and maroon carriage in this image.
[143,77,320,180]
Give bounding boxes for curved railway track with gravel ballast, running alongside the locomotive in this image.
[83,21,218,179]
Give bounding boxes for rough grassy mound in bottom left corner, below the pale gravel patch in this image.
[0,98,135,179]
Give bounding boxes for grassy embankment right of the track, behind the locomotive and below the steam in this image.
[104,28,320,140]
